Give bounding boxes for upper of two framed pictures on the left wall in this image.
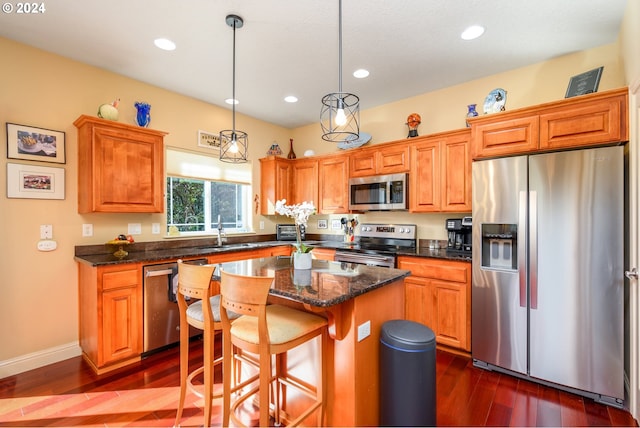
[7,123,66,163]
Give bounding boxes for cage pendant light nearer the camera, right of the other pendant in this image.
[320,0,360,142]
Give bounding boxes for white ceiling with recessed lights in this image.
[0,0,627,129]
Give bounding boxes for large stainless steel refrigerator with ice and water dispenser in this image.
[471,146,624,407]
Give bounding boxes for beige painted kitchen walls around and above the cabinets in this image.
[0,19,625,378]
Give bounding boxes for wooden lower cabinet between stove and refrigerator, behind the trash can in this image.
[398,256,471,352]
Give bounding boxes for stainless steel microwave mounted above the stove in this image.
[349,174,409,211]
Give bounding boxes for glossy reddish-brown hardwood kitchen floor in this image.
[0,343,637,427]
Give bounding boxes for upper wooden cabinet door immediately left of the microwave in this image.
[318,156,349,214]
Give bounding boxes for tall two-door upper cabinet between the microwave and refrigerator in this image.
[409,129,471,212]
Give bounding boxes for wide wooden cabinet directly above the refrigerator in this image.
[469,88,629,159]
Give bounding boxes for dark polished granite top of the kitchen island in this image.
[214,256,411,308]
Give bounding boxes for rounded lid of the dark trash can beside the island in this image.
[380,320,436,351]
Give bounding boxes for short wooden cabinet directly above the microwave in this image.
[349,144,410,177]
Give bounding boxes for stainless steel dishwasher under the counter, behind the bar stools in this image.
[142,259,207,356]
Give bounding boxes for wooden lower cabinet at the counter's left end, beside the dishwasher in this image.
[78,263,142,373]
